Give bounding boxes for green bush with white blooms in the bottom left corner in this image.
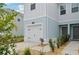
[0,35,17,55]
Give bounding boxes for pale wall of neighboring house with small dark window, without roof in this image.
[12,13,24,36]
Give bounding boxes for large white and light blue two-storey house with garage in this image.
[24,3,79,42]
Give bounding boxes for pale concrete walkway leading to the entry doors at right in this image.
[62,41,79,55]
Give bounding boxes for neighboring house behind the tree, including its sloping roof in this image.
[0,8,24,36]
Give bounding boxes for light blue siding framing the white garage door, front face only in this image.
[24,17,47,39]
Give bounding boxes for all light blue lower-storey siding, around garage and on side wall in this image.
[24,17,59,41]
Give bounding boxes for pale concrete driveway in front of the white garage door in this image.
[16,41,51,53]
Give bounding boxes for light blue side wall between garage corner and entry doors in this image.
[47,17,59,40]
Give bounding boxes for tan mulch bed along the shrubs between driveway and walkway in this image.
[19,42,69,55]
